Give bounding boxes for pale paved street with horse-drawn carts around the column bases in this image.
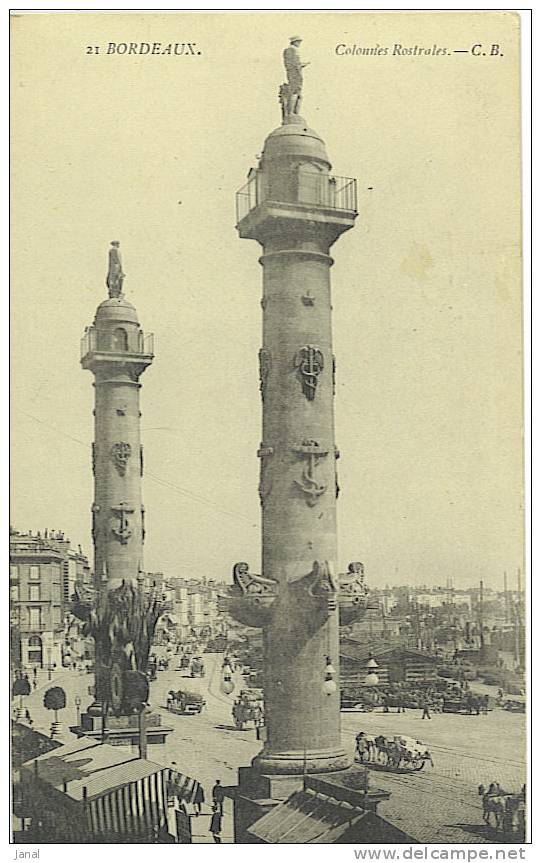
[19,651,526,842]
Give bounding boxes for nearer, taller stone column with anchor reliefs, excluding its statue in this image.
[221,109,367,788]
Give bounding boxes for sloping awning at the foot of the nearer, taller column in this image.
[248,789,368,845]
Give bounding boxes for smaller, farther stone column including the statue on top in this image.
[73,242,170,742]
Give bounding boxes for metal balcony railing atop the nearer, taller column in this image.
[237,170,357,223]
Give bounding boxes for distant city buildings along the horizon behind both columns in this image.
[10,529,525,685]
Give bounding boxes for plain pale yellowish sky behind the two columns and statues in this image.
[11,13,523,587]
